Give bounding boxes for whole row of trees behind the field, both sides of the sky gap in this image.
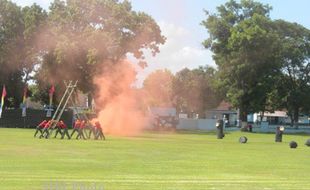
[0,0,310,127]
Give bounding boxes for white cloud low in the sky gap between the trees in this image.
[131,22,215,86]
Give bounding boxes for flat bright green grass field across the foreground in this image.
[0,128,310,190]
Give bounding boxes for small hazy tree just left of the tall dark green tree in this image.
[172,67,221,117]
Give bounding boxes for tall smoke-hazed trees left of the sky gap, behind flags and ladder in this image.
[0,0,165,108]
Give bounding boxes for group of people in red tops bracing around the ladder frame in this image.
[34,119,105,140]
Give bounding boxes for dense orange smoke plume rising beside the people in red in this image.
[94,61,147,136]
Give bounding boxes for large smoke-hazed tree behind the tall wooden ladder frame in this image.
[36,0,165,101]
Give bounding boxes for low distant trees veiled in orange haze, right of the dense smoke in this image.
[142,66,223,118]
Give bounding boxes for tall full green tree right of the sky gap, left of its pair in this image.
[202,0,280,121]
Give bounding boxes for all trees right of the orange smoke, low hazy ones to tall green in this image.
[144,0,310,125]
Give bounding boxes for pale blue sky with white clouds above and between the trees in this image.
[13,0,310,83]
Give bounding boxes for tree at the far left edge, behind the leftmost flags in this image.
[0,0,44,108]
